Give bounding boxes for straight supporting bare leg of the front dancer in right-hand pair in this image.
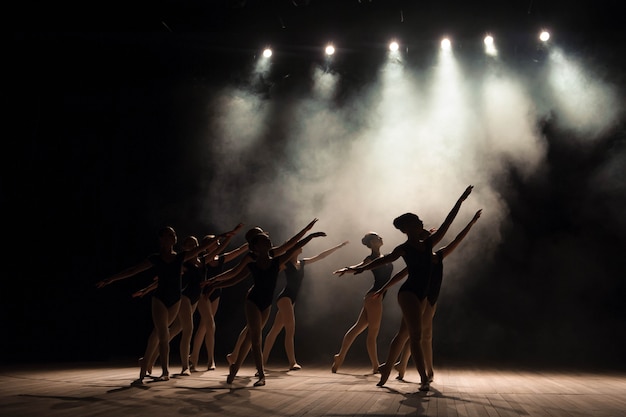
[398,291,429,391]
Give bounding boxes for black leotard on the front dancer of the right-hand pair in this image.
[398,237,433,300]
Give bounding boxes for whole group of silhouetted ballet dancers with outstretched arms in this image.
[97,186,482,391]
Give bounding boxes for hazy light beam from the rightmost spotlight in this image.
[548,47,624,139]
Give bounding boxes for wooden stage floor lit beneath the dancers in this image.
[0,363,626,417]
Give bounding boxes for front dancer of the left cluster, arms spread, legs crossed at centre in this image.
[204,226,326,386]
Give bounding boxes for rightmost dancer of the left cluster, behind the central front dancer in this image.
[263,241,348,371]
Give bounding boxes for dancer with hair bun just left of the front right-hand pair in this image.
[331,232,393,373]
